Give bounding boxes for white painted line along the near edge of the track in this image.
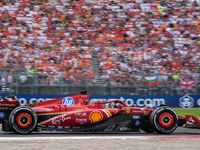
[0,136,148,141]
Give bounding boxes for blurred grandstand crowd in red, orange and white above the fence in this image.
[0,0,200,85]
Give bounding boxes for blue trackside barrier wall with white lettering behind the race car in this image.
[1,95,200,108]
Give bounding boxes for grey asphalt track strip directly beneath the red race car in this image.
[0,125,200,140]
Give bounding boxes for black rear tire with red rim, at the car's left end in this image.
[8,106,37,134]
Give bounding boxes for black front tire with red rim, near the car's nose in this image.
[150,106,178,134]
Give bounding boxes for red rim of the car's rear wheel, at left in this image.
[16,113,32,129]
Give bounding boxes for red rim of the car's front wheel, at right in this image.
[159,112,174,128]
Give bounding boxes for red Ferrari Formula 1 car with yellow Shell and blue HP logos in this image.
[0,92,200,134]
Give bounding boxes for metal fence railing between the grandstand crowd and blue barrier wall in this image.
[0,72,200,95]
